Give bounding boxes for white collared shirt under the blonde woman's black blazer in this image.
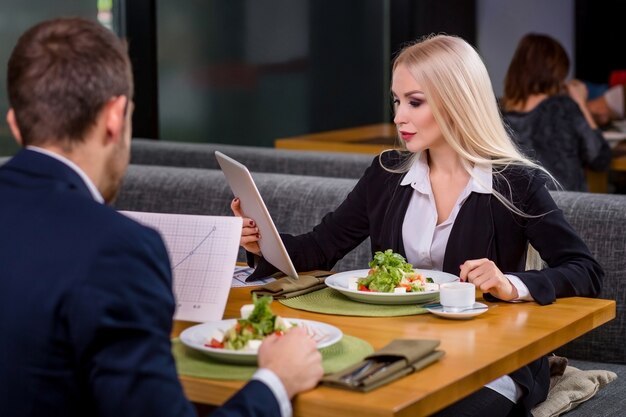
[400,153,532,403]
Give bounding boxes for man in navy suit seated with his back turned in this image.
[0,18,322,417]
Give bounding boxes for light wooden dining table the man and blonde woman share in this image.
[174,287,615,417]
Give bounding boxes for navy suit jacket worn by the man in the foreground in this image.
[0,150,280,417]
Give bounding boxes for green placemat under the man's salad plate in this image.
[172,334,374,381]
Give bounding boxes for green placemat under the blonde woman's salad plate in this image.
[278,288,432,317]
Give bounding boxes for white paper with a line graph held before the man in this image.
[122,211,241,321]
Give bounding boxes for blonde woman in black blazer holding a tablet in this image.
[231,35,603,417]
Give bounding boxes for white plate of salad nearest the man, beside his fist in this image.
[180,318,343,365]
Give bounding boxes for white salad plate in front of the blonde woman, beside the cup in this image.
[325,269,459,304]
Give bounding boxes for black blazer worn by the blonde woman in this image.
[254,153,604,415]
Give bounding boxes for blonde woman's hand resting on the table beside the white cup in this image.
[460,258,519,301]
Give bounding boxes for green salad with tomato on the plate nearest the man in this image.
[205,294,295,350]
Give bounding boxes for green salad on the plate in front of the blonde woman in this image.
[357,249,433,292]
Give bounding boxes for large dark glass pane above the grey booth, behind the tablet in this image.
[157,0,390,146]
